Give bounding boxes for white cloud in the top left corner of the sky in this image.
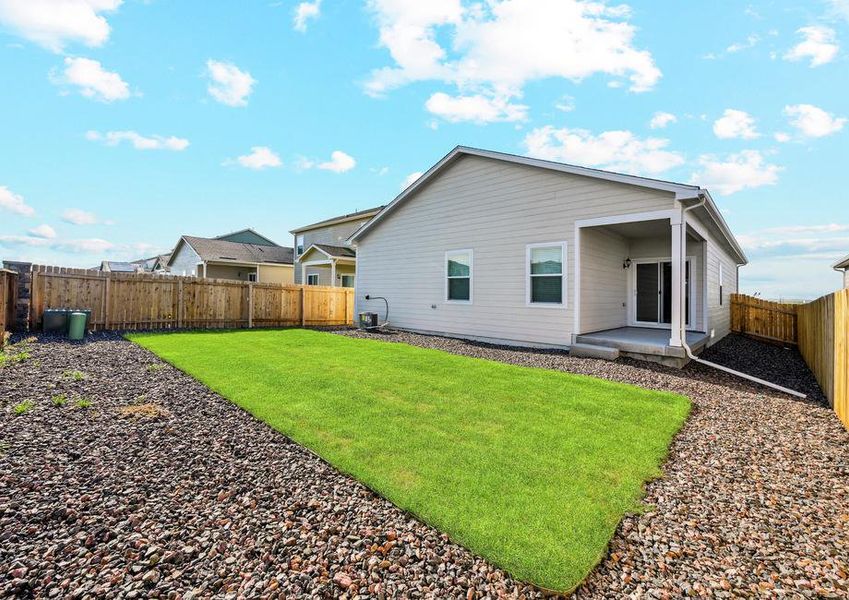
[0,0,122,52]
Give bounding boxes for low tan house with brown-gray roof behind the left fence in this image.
[166,229,294,283]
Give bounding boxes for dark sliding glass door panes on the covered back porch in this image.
[634,260,690,325]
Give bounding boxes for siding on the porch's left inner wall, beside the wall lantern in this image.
[581,227,629,331]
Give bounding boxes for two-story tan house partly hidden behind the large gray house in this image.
[290,206,383,287]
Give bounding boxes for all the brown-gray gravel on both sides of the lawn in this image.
[0,331,849,598]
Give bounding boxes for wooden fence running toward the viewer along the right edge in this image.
[797,290,849,428]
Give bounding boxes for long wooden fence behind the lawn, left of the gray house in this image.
[25,265,354,330]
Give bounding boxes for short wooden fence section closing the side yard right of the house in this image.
[731,294,797,344]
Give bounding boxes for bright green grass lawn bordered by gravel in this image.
[129,329,690,591]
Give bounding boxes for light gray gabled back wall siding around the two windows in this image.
[356,156,675,346]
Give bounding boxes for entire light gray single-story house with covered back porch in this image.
[350,147,747,366]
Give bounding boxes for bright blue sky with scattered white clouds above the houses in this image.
[0,0,849,298]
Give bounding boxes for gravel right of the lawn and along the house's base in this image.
[340,330,849,598]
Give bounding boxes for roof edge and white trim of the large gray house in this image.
[348,146,748,264]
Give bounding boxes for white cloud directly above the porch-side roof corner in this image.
[690,150,781,196]
